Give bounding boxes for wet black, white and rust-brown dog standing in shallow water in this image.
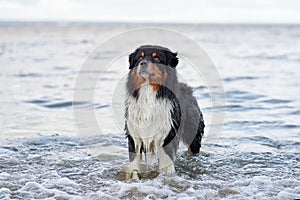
[125,45,205,179]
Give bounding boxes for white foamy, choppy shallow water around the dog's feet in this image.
[0,135,300,199]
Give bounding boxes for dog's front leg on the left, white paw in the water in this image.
[126,135,141,180]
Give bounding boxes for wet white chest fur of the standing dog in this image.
[127,84,172,153]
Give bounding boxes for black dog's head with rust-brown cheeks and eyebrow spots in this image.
[129,45,178,88]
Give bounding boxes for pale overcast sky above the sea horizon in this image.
[0,0,300,23]
